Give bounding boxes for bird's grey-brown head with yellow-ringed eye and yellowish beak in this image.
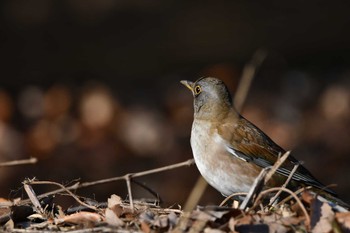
[181,77,232,119]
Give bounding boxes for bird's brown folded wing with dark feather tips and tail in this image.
[218,116,335,195]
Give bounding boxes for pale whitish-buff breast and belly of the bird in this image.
[191,123,259,196]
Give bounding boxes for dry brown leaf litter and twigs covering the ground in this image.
[0,157,350,233]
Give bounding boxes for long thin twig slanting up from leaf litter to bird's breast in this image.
[14,159,194,207]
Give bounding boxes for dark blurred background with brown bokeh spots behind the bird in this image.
[0,0,350,206]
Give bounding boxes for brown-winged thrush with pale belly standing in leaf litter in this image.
[181,77,346,208]
